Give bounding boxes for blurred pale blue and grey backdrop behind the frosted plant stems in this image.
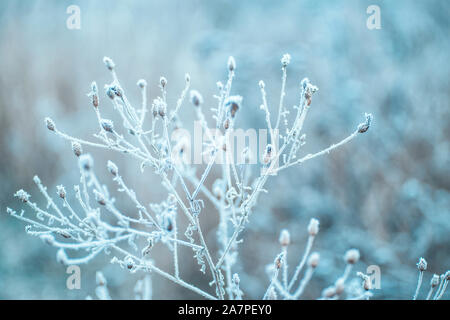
[0,0,450,299]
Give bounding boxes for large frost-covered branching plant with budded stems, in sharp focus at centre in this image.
[7,54,372,299]
